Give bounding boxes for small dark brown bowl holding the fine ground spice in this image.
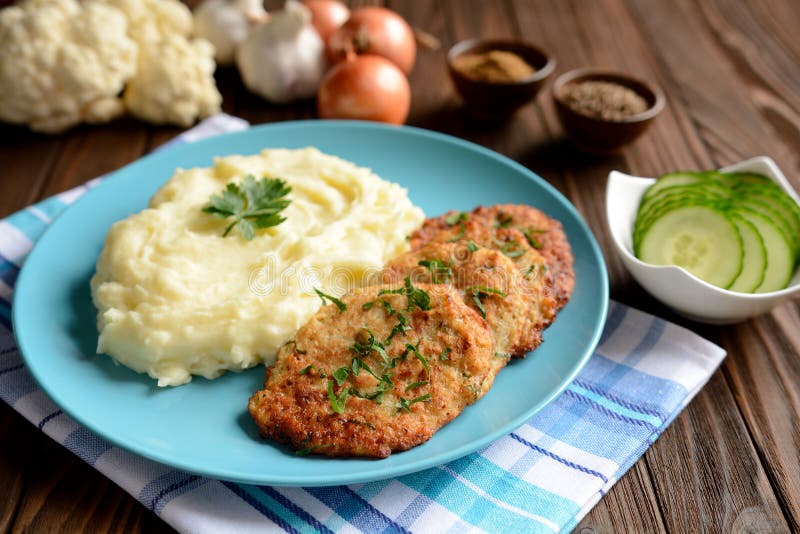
[447,39,556,120]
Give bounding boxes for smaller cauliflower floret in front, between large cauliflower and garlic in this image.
[124,35,222,127]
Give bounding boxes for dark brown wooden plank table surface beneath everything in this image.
[0,0,800,534]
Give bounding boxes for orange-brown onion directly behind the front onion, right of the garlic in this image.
[327,6,417,74]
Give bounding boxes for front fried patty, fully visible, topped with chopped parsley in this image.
[248,278,502,458]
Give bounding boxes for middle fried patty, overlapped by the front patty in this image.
[381,245,536,355]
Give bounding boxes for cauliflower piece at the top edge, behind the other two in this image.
[94,0,194,45]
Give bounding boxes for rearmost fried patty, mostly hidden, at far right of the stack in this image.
[409,204,575,312]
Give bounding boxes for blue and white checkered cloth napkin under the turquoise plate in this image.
[0,115,725,534]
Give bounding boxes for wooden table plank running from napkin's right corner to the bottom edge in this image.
[645,372,789,532]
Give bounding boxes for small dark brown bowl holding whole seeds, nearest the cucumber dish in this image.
[553,68,666,154]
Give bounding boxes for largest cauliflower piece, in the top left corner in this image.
[0,0,137,132]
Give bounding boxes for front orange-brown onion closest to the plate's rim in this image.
[317,55,411,124]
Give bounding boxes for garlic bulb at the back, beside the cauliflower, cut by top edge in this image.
[194,0,268,65]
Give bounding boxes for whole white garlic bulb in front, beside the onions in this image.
[236,0,325,103]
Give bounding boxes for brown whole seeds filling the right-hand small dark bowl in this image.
[558,81,648,121]
